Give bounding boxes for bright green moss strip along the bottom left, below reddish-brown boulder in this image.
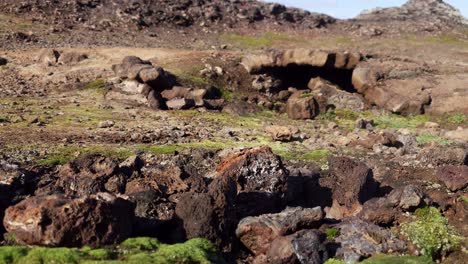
[0,237,224,264]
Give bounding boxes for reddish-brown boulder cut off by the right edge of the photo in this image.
[436,165,468,192]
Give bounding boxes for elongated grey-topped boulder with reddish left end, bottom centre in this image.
[236,207,323,255]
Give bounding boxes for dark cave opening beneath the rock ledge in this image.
[262,64,356,93]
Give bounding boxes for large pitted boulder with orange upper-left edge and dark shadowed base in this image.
[216,147,288,219]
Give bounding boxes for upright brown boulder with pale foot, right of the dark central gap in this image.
[327,157,377,219]
